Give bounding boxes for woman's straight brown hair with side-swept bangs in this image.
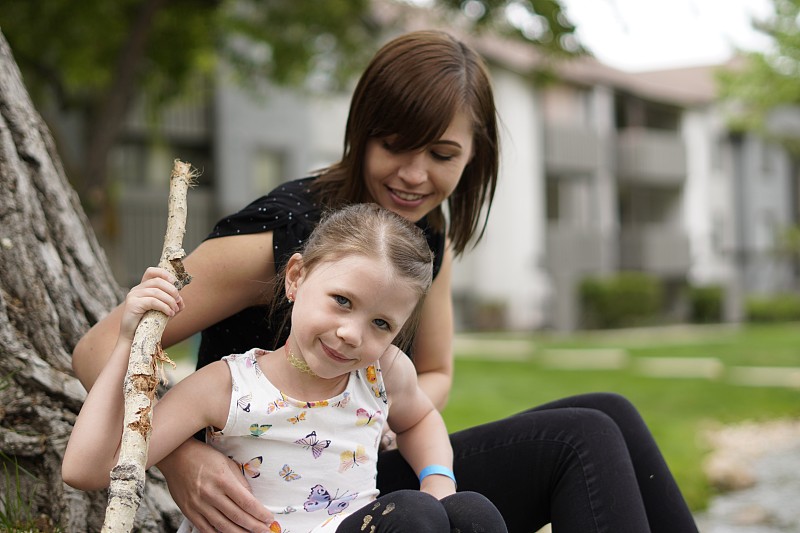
[315,31,499,255]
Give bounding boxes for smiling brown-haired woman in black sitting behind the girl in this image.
[73,32,696,533]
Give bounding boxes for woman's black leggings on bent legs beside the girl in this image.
[378,393,697,533]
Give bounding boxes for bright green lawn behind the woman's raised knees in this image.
[444,324,800,510]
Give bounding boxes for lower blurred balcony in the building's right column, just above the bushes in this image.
[620,226,691,277]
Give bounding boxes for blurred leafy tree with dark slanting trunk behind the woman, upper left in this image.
[0,0,580,224]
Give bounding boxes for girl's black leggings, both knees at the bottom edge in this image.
[336,490,507,533]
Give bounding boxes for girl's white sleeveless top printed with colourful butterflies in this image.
[177,349,388,533]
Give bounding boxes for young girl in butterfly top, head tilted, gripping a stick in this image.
[63,204,506,533]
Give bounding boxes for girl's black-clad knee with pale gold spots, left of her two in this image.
[336,490,450,533]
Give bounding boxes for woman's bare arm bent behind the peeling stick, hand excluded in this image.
[72,232,275,390]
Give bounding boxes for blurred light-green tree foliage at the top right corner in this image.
[718,0,800,148]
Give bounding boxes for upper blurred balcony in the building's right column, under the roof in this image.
[617,128,687,187]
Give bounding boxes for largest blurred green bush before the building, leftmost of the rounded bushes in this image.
[579,272,664,329]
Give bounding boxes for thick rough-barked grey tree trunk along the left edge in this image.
[0,33,180,532]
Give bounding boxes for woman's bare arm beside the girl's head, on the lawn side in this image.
[410,247,453,408]
